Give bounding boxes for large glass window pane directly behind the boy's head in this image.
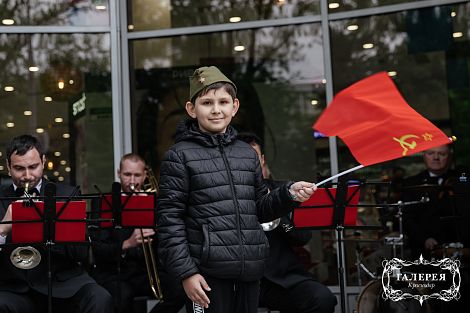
[131,25,329,180]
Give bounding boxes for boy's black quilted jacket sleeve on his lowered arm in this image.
[157,150,199,279]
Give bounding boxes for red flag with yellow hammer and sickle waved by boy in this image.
[313,72,451,166]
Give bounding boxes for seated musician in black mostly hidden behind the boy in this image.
[238,133,337,313]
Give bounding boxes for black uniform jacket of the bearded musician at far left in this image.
[0,179,94,298]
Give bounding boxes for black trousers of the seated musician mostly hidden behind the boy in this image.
[260,278,337,313]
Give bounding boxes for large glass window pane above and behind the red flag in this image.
[330,4,470,175]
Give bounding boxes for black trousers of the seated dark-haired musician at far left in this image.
[0,283,113,313]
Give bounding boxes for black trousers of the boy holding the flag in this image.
[186,276,259,313]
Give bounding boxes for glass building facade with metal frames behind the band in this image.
[0,0,470,308]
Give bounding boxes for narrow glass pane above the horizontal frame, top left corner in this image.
[0,0,109,26]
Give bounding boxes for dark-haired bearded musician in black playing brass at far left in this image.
[0,135,112,313]
